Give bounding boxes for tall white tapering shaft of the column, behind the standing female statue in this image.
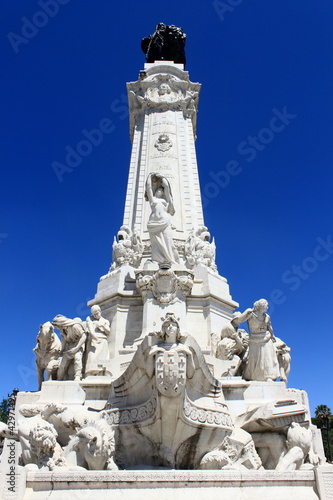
[123,61,204,246]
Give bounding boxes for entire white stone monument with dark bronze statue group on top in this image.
[0,23,333,500]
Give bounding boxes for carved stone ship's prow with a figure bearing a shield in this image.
[105,312,233,468]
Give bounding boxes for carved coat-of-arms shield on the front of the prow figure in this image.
[155,350,186,397]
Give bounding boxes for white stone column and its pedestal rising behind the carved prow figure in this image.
[89,60,238,373]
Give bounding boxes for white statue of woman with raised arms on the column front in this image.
[145,172,179,265]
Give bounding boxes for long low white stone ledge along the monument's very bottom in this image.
[23,466,333,500]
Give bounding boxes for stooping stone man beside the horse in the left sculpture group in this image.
[52,314,86,380]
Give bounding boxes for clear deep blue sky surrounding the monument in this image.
[0,0,333,411]
